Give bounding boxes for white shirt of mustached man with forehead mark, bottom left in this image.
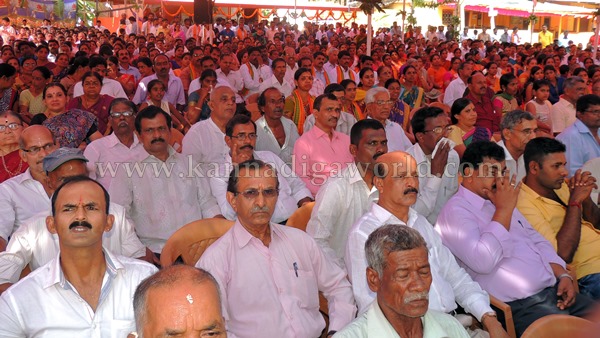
[0,251,157,338]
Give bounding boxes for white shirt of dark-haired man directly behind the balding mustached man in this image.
[306,163,379,269]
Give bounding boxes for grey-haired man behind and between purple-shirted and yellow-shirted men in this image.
[498,110,537,182]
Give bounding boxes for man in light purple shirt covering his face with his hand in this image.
[436,141,592,336]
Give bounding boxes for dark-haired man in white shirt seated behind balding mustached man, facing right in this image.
[306,119,388,269]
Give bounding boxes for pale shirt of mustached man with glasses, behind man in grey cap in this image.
[83,133,144,190]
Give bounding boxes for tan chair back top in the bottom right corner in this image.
[521,315,594,338]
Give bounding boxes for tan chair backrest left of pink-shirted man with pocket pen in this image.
[160,218,234,268]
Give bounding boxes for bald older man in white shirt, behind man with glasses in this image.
[182,86,236,172]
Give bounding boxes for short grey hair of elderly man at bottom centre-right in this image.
[365,224,427,278]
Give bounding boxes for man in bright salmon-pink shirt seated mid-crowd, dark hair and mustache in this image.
[293,94,353,196]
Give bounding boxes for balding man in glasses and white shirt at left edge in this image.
[0,125,58,251]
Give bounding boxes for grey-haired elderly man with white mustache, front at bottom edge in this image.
[334,224,469,338]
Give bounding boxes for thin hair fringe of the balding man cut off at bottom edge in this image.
[133,265,221,338]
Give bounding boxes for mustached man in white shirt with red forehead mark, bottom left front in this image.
[0,176,156,338]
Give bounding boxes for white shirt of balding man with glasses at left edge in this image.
[0,169,50,240]
